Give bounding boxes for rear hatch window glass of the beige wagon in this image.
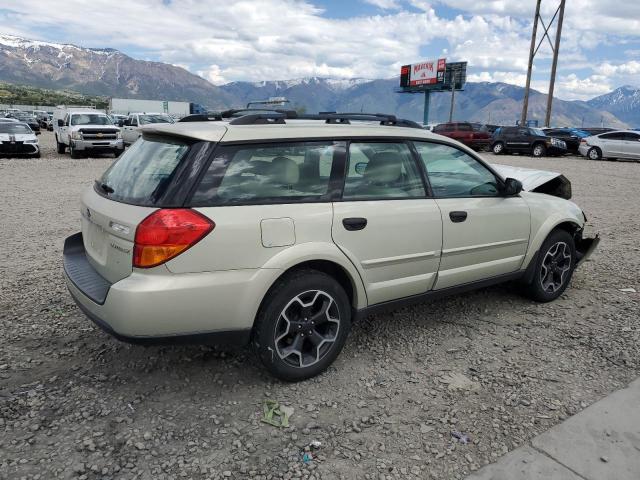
[96,137,190,206]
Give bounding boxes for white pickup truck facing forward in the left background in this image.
[53,108,124,158]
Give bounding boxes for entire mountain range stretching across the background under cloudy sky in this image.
[0,35,640,127]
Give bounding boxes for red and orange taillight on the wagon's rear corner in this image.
[133,209,216,268]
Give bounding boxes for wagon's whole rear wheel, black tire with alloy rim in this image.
[251,269,351,382]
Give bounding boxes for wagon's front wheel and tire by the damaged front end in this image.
[525,229,576,303]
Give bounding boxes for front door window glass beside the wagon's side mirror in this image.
[414,142,499,198]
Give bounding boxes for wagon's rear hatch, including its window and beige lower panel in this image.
[81,136,205,283]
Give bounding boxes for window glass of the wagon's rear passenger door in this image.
[343,143,425,199]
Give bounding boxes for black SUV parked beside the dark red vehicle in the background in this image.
[491,127,567,157]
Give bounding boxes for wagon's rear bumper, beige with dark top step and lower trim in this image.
[63,233,258,345]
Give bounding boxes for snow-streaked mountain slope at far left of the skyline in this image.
[0,35,232,107]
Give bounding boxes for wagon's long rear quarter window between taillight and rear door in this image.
[192,142,345,205]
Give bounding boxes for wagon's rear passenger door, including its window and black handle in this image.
[332,141,442,305]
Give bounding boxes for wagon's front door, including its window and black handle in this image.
[414,142,531,290]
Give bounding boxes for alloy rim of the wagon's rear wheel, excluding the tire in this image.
[275,290,340,368]
